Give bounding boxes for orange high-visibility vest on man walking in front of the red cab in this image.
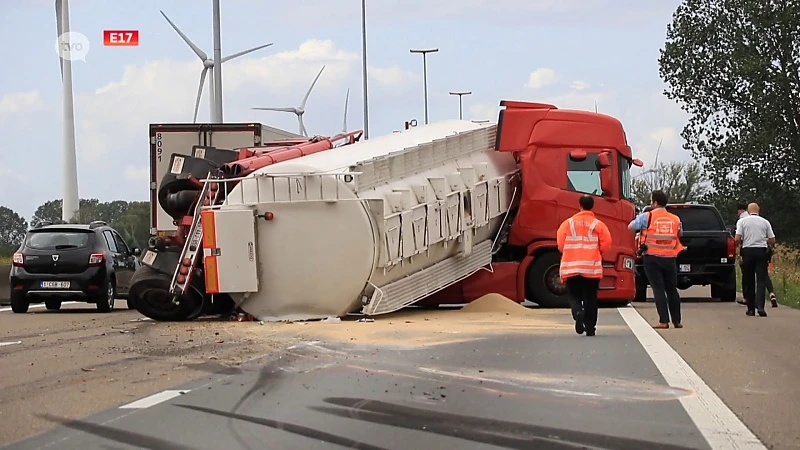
[559,213,603,280]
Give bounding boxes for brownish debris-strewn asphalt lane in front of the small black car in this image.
[0,300,278,448]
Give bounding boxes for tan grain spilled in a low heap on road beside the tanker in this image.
[250,294,573,348]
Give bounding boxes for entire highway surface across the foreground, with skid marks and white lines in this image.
[0,289,800,450]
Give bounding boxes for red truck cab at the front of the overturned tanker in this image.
[424,101,642,307]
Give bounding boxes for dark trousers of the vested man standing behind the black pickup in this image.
[643,255,681,323]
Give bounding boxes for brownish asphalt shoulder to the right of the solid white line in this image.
[635,287,800,449]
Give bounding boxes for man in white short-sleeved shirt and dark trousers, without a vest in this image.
[735,203,775,317]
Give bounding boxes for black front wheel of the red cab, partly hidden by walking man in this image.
[525,252,569,308]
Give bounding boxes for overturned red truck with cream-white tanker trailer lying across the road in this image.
[130,101,642,321]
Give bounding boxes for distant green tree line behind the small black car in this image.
[0,198,150,257]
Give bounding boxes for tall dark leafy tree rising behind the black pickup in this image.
[659,0,800,190]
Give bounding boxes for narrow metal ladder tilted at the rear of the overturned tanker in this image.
[169,172,222,298]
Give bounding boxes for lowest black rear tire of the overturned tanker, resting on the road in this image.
[128,266,202,322]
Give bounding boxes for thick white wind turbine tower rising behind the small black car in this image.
[55,0,80,222]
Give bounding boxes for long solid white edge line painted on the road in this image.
[617,308,766,450]
